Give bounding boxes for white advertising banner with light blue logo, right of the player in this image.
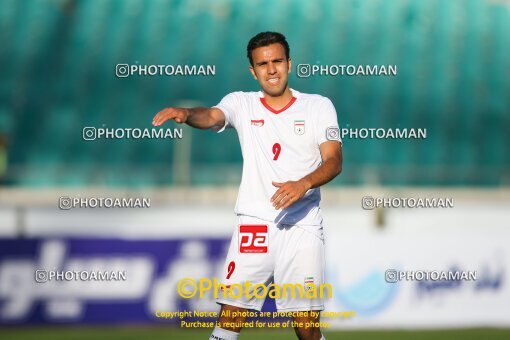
[323,228,510,328]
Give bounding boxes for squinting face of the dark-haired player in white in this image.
[250,43,292,97]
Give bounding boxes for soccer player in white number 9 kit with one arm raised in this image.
[153,32,342,340]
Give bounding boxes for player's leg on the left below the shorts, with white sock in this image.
[209,305,247,340]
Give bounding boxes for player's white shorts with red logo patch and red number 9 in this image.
[217,216,328,312]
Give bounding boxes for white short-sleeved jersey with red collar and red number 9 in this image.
[215,89,340,226]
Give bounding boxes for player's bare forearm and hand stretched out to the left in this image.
[152,107,225,129]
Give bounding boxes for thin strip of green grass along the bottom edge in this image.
[0,326,510,340]
